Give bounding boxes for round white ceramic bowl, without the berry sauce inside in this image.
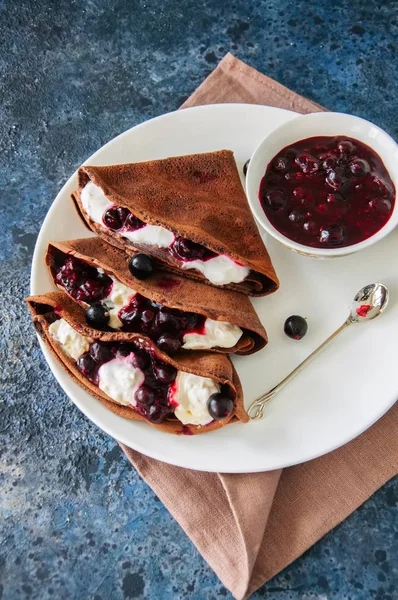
[246,112,398,258]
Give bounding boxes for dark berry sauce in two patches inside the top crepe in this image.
[102,204,218,262]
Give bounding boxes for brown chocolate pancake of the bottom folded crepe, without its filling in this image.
[26,292,249,434]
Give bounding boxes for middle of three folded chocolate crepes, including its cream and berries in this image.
[46,237,267,354]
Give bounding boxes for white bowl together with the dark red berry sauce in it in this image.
[246,112,398,258]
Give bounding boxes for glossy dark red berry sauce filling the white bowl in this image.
[259,136,395,248]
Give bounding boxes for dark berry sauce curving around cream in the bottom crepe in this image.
[76,342,177,423]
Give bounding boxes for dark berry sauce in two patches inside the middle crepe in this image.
[52,252,206,353]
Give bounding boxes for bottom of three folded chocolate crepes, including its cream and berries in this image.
[26,292,248,435]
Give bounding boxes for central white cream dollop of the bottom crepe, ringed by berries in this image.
[98,353,145,406]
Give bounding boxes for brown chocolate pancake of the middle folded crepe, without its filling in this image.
[46,237,268,354]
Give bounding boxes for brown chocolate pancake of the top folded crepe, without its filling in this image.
[73,150,279,296]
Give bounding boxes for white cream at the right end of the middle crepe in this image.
[182,319,243,350]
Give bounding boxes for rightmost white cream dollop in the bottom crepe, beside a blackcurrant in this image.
[170,371,220,425]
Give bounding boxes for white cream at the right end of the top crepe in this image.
[181,254,250,285]
